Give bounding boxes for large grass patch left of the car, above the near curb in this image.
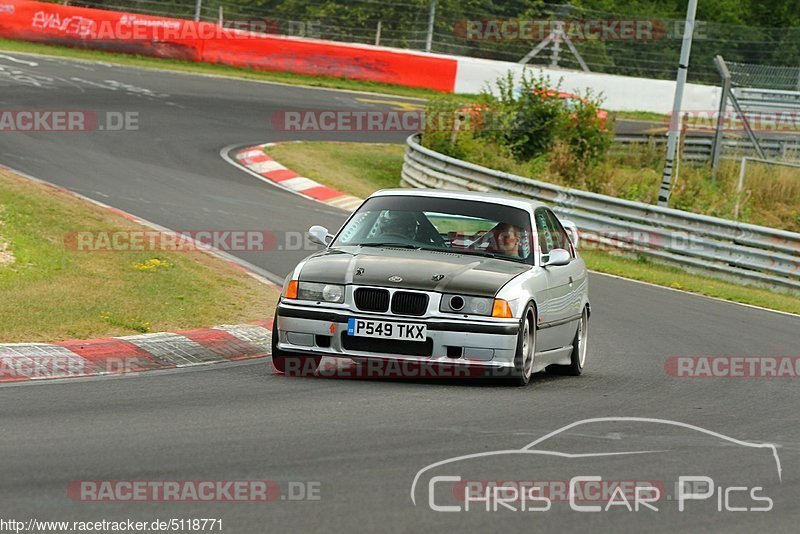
[0,171,277,342]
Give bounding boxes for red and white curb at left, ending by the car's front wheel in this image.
[0,321,272,383]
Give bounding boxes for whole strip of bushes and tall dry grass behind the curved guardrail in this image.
[422,76,800,232]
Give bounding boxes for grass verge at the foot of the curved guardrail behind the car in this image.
[267,142,800,313]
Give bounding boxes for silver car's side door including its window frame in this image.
[534,208,583,351]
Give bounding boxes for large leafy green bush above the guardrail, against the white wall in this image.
[422,71,612,177]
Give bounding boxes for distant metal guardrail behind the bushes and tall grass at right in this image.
[611,134,800,163]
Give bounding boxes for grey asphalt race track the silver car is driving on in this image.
[0,54,800,532]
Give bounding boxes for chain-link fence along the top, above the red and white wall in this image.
[59,0,800,85]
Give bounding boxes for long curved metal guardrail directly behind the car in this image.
[402,134,800,291]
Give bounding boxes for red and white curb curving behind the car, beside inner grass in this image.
[236,143,363,211]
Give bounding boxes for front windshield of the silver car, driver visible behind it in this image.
[331,196,534,263]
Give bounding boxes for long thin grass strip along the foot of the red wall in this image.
[0,39,466,101]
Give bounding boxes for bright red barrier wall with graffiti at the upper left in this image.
[0,0,457,92]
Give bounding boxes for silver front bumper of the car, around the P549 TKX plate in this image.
[273,301,519,369]
